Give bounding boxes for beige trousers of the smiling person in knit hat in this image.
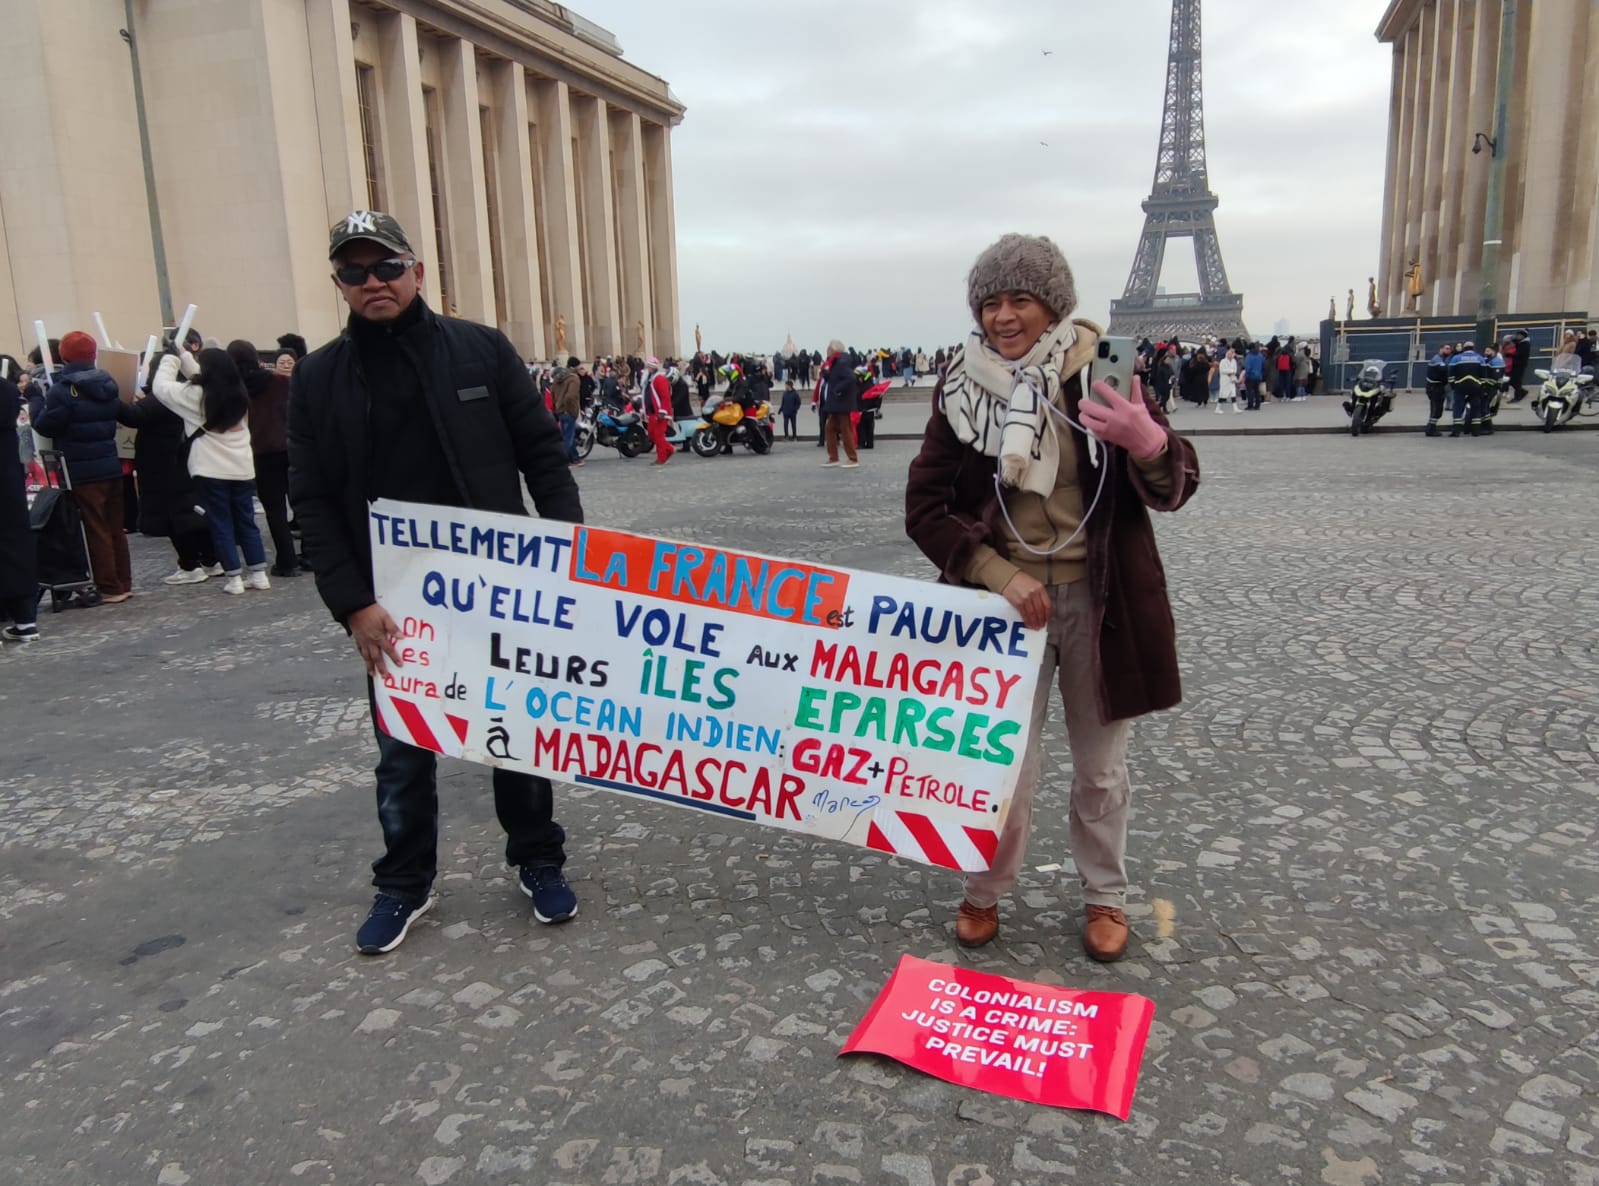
[966,580,1132,906]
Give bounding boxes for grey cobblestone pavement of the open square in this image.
[0,433,1599,1186]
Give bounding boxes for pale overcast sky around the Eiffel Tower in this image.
[572,0,1393,352]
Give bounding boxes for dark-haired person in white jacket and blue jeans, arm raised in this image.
[150,350,272,593]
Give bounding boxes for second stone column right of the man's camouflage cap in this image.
[437,38,499,324]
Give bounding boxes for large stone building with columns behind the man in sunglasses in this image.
[0,0,683,360]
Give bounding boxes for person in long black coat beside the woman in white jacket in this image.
[123,374,222,585]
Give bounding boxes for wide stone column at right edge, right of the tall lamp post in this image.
[1511,0,1593,313]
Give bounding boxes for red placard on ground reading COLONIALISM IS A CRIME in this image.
[839,956,1154,1120]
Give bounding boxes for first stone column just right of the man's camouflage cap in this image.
[377,13,440,308]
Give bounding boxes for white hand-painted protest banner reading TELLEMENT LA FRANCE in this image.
[369,499,1044,870]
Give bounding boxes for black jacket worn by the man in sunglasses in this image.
[289,297,584,622]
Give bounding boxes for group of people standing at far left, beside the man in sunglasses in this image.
[0,329,305,643]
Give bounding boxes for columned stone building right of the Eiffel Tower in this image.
[1377,0,1599,316]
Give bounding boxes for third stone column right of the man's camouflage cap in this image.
[489,62,547,360]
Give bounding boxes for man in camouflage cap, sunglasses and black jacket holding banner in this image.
[289,211,584,954]
